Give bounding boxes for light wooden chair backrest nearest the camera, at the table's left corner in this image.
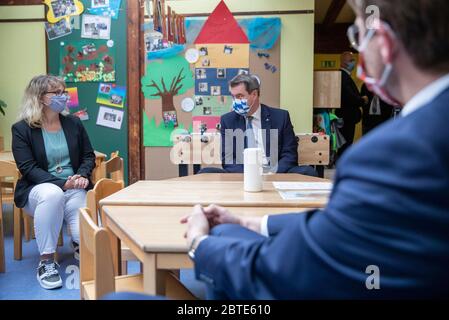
[80,208,115,299]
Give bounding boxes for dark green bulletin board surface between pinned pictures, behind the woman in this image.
[47,0,128,184]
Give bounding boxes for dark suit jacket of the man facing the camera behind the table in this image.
[220,104,298,173]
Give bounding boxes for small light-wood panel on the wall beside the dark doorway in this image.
[313,70,341,109]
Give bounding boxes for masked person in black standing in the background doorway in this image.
[335,51,368,157]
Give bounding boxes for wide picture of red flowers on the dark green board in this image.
[59,41,115,82]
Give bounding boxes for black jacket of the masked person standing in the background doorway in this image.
[335,70,365,126]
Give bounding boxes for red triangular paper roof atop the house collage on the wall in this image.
[195,1,249,44]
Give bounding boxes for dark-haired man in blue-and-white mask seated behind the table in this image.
[200,74,317,176]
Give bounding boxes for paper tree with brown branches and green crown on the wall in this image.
[141,56,195,113]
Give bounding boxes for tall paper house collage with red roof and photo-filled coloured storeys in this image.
[192,2,249,133]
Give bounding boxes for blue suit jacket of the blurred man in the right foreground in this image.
[195,90,449,299]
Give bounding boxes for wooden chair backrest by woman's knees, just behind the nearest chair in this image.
[86,178,124,225]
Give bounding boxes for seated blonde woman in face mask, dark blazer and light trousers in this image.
[12,75,95,289]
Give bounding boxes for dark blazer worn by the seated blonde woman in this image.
[12,115,95,208]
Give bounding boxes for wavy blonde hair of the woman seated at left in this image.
[19,75,65,128]
